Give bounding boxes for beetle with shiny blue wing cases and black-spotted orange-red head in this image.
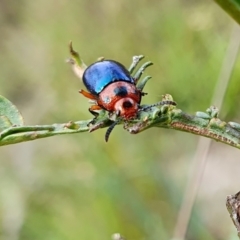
[79,60,176,141]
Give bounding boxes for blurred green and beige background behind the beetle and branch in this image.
[0,0,240,240]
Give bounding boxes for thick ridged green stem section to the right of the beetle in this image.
[127,104,240,148]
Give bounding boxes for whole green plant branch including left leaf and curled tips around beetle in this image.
[0,42,240,148]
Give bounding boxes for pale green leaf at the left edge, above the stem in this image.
[0,95,23,132]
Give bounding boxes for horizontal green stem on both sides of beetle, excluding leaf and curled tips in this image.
[0,95,240,148]
